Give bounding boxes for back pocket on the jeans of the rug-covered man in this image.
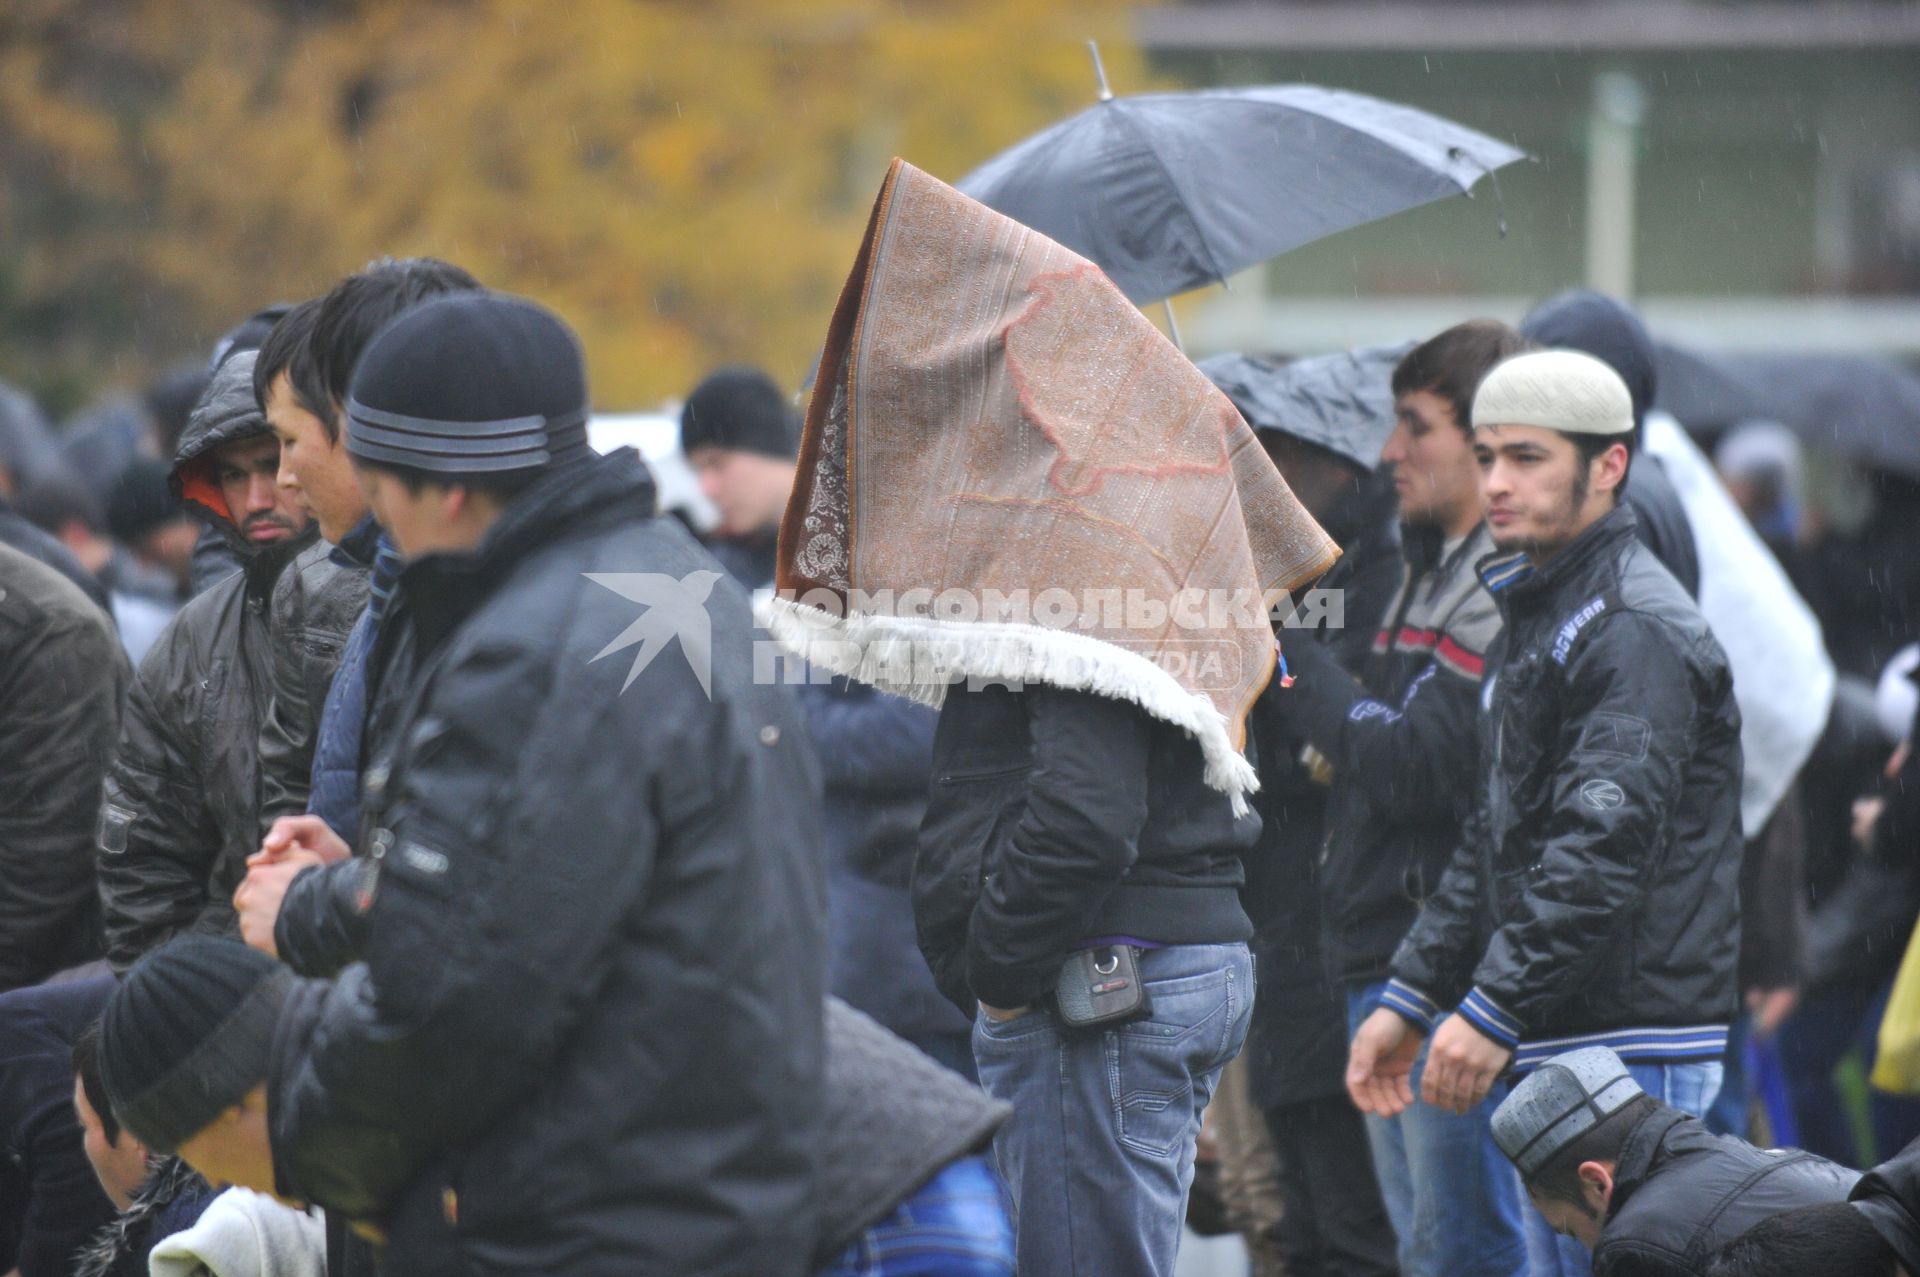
[1106,972,1233,1158]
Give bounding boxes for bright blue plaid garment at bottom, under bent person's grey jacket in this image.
[814,1158,1014,1277]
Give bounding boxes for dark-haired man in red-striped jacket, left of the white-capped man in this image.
[1283,319,1526,1277]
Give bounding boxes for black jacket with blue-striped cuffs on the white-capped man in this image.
[1386,509,1741,1070]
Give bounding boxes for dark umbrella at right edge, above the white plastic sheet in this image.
[1655,342,1920,478]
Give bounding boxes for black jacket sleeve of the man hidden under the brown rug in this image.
[968,687,1152,1006]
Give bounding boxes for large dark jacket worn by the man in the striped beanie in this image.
[269,451,826,1277]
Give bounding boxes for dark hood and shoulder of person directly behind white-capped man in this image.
[1521,290,1699,599]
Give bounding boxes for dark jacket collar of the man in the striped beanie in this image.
[397,447,655,655]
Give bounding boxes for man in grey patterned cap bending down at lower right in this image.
[1494,1047,1859,1277]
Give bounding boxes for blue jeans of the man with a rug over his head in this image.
[973,945,1254,1277]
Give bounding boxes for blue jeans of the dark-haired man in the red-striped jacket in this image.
[1346,981,1526,1277]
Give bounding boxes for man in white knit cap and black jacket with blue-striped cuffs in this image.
[1348,351,1741,1277]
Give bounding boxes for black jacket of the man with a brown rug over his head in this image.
[914,686,1260,1014]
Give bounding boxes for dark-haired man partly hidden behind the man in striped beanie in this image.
[253,257,480,837]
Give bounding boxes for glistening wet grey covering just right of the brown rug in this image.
[1198,342,1415,470]
